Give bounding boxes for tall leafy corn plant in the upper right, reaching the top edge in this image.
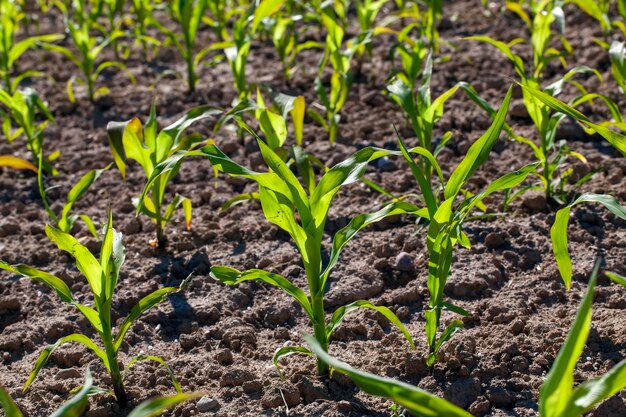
[466,0,623,204]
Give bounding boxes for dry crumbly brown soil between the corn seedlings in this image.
[0,0,626,417]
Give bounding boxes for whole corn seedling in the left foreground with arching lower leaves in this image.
[0,212,186,405]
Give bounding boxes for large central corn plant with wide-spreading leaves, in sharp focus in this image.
[144,132,415,376]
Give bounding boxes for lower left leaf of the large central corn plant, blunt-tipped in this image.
[210,266,313,320]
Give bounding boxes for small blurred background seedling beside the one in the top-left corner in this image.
[43,9,135,102]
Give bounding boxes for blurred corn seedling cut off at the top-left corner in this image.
[0,1,63,95]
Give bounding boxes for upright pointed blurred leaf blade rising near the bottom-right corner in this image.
[539,262,599,417]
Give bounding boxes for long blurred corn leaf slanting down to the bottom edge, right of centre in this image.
[304,335,471,417]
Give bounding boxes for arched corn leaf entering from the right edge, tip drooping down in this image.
[550,193,626,289]
